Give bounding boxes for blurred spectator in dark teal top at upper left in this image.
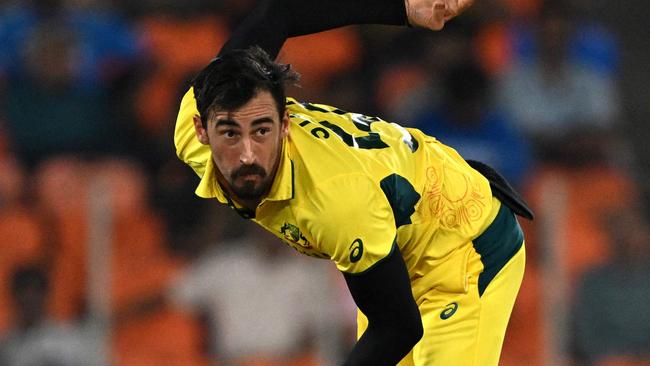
[2,23,110,168]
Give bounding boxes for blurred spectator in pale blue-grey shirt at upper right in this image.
[497,0,621,162]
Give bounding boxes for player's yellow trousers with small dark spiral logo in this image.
[357,245,526,366]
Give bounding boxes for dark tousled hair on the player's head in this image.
[192,46,300,127]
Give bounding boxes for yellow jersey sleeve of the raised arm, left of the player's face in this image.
[174,88,211,177]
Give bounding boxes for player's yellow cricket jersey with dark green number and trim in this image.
[174,89,500,300]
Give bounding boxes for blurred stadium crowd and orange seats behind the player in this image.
[0,0,650,366]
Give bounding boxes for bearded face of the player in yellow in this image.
[194,91,289,201]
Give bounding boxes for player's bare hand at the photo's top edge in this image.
[404,0,474,30]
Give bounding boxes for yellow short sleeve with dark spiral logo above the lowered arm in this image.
[303,174,397,273]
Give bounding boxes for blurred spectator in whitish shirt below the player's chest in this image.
[169,222,343,365]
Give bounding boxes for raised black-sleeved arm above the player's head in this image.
[220,0,406,58]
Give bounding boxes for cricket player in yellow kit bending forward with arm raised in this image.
[174,0,532,366]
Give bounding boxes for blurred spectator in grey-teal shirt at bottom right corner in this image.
[574,207,650,366]
